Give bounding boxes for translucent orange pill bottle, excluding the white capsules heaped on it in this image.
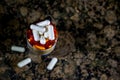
[26,17,58,55]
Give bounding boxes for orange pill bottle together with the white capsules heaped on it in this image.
[27,20,58,55]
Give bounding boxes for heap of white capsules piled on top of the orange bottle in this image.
[30,20,55,44]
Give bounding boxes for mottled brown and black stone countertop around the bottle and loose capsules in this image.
[0,0,120,80]
